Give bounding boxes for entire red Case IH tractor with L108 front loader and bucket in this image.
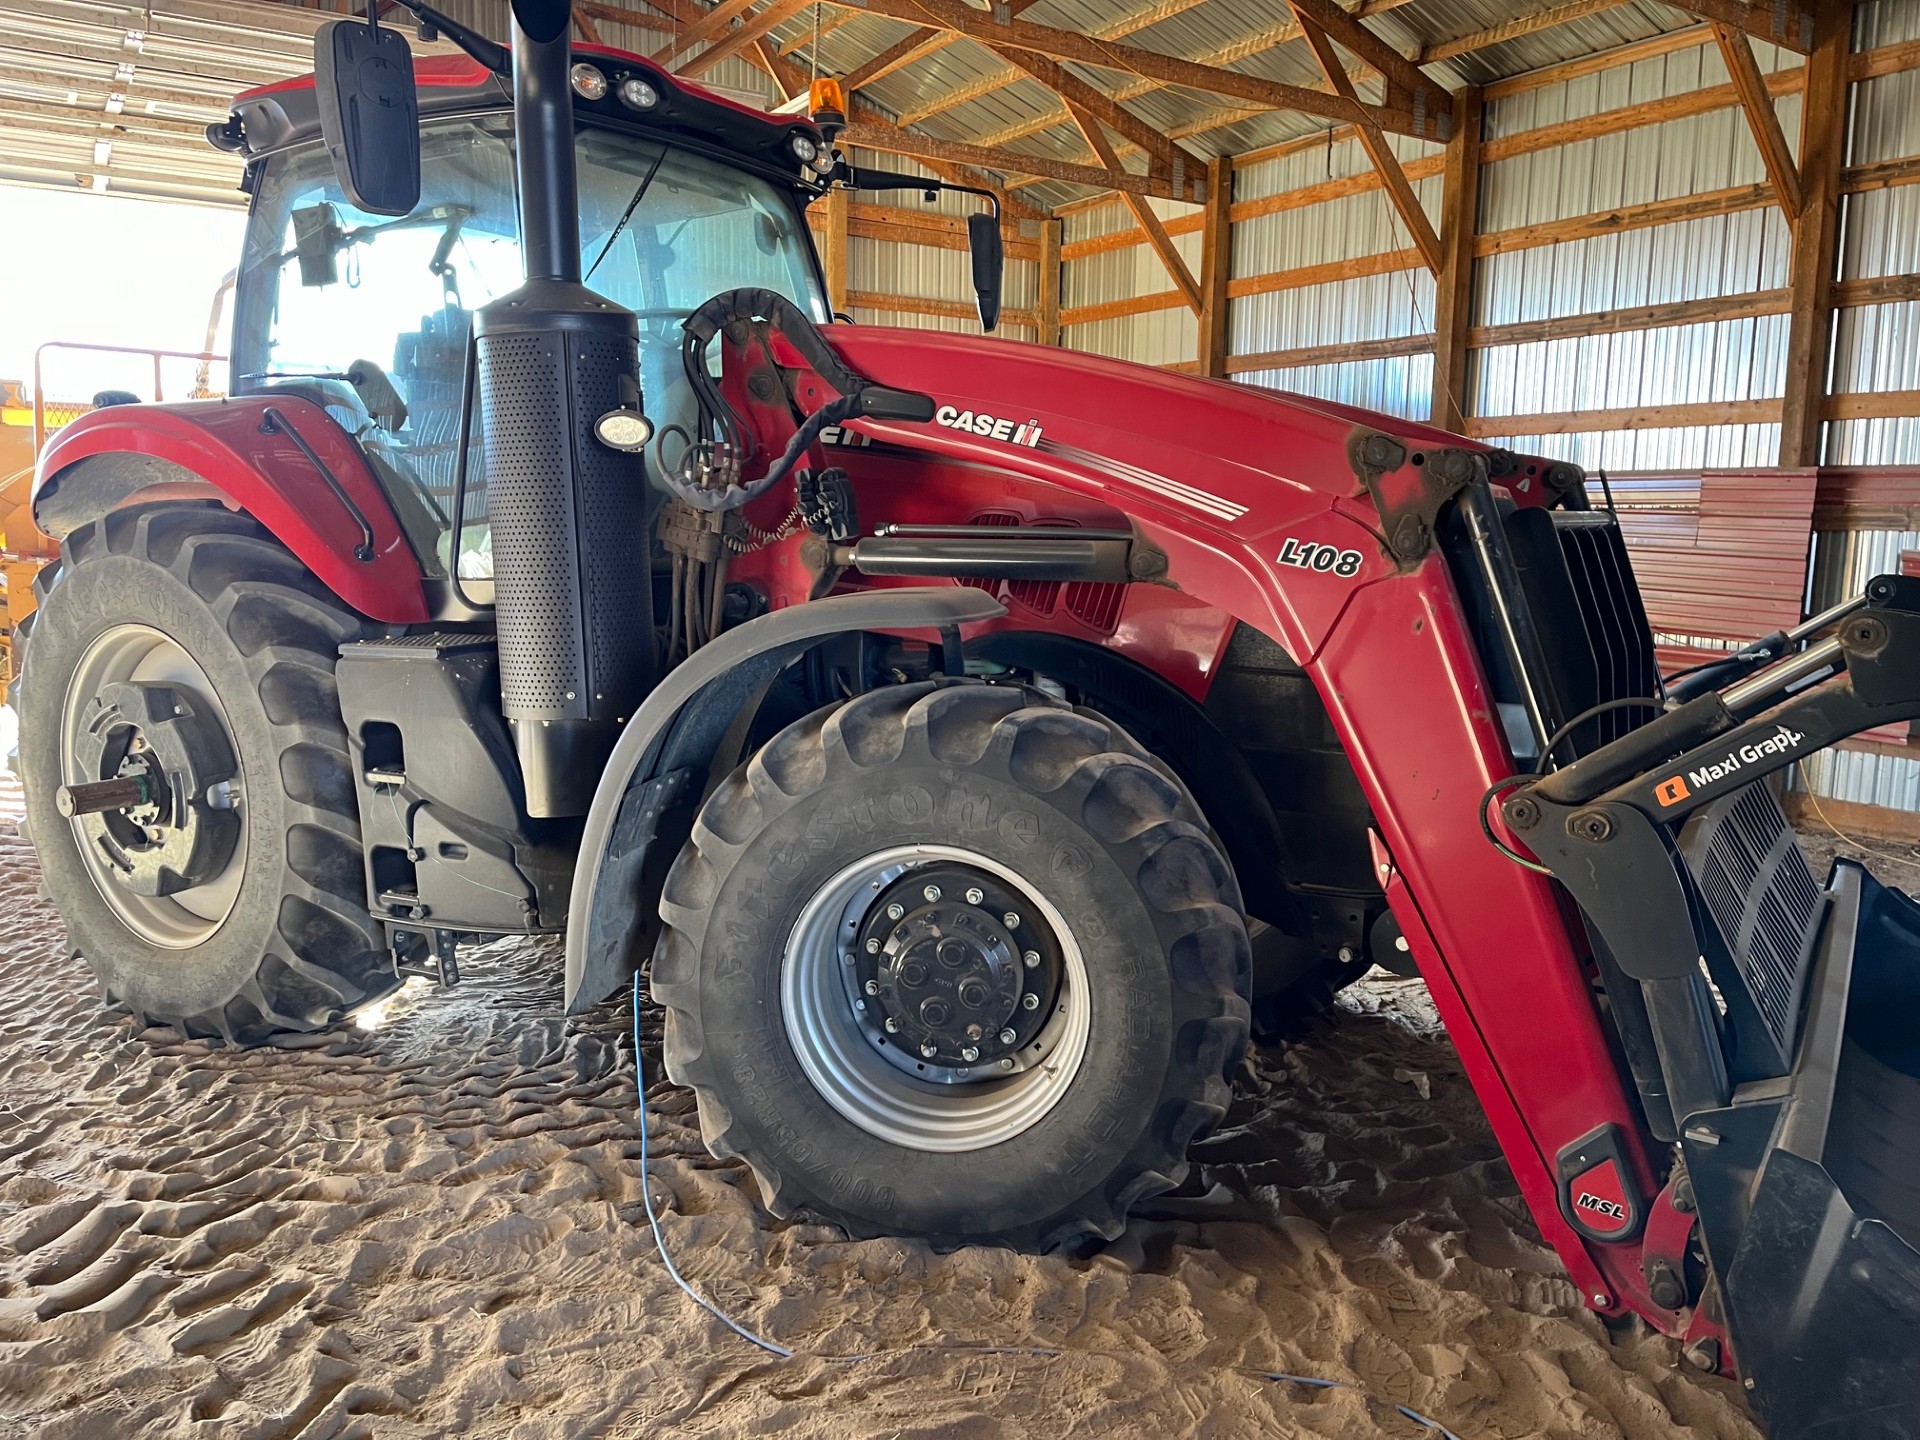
[17,0,1920,1438]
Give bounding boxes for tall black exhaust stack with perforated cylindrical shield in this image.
[474,0,655,816]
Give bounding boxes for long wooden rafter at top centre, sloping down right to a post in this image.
[817,0,1421,134]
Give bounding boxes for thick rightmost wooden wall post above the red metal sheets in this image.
[1780,4,1853,468]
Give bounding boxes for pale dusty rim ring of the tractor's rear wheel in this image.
[60,624,248,950]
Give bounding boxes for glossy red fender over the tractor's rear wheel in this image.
[33,394,430,624]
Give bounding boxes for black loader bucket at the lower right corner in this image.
[1682,860,1920,1440]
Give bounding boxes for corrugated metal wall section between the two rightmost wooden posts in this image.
[1469,42,1799,470]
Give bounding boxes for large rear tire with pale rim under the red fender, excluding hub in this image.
[19,505,397,1044]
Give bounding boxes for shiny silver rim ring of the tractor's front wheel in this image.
[780,845,1092,1154]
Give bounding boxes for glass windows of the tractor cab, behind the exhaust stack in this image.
[232,115,828,580]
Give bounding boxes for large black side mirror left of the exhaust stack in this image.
[313,19,420,215]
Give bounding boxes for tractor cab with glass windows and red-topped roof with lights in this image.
[219,48,828,605]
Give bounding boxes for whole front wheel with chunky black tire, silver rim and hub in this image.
[653,682,1248,1250]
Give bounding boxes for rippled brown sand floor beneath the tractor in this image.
[0,791,1759,1440]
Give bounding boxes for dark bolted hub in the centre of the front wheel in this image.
[847,864,1062,1081]
